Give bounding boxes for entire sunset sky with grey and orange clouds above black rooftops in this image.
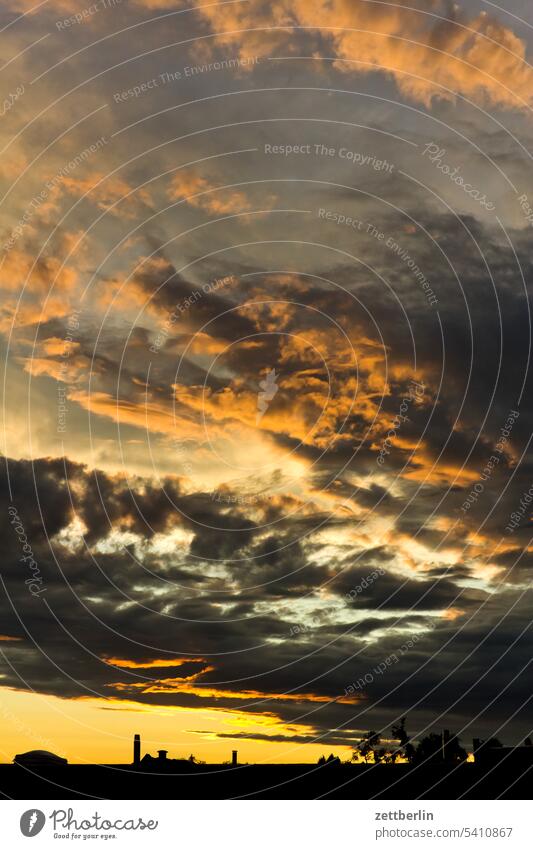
[0,0,533,762]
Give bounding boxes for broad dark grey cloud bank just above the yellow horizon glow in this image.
[0,448,528,745]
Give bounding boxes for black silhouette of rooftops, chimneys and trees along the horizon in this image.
[4,719,533,799]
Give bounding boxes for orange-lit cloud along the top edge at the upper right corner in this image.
[181,0,533,108]
